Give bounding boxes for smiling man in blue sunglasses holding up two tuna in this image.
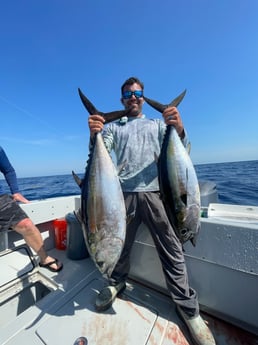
[88,77,215,345]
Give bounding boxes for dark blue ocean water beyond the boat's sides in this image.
[0,160,258,206]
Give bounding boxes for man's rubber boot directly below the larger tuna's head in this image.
[95,282,126,311]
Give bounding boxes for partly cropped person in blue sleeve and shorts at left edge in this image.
[0,146,63,272]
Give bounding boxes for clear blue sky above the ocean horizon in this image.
[0,0,258,177]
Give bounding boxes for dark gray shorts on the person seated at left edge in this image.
[0,194,28,231]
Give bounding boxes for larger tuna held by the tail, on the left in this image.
[73,89,128,277]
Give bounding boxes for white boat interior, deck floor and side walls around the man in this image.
[0,196,258,345]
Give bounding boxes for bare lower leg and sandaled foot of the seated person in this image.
[13,218,61,269]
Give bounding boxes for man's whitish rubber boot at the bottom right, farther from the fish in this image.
[177,306,216,345]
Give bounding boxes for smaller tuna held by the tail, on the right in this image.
[144,91,200,245]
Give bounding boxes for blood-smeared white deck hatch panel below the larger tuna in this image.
[36,279,157,345]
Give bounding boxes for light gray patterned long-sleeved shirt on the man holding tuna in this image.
[103,115,188,192]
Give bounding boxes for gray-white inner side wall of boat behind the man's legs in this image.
[131,210,258,335]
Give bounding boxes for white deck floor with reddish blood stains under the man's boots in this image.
[0,249,258,345]
